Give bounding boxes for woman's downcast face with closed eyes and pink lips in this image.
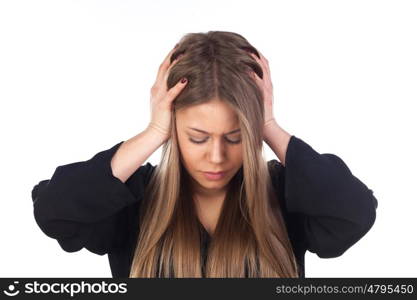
[176,99,243,195]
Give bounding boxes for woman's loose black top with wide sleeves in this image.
[32,135,378,278]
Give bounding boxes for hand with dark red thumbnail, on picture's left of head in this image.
[148,47,187,139]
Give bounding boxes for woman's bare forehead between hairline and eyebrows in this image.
[176,100,239,134]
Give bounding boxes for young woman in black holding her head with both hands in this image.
[32,31,378,277]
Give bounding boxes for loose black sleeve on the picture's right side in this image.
[269,136,378,258]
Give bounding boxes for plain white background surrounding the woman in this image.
[0,0,417,277]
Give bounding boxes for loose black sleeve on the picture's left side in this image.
[32,141,154,255]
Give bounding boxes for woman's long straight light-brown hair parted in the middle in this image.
[129,31,298,278]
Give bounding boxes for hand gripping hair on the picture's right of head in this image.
[249,51,276,129]
